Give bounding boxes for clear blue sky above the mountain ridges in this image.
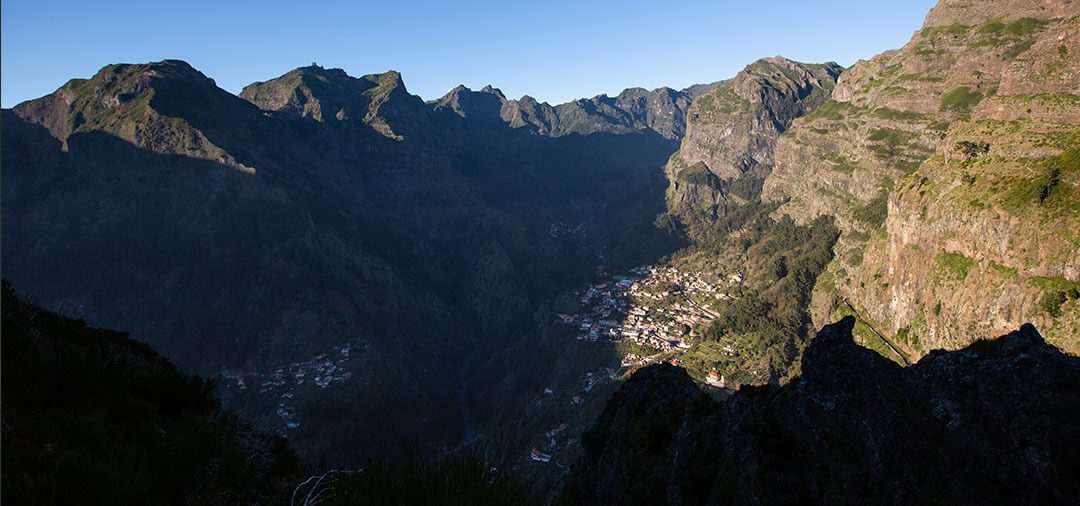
[0,0,936,107]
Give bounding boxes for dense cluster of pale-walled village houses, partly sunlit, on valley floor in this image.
[529,265,742,467]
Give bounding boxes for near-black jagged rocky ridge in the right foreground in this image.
[561,316,1080,504]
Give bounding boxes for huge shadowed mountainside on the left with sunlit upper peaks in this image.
[0,60,674,462]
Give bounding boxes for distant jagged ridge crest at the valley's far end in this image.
[429,81,708,140]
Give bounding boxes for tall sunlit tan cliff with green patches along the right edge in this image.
[762,0,1080,357]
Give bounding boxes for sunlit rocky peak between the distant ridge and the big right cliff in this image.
[665,56,842,235]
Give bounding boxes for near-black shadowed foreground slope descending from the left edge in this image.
[0,281,306,504]
